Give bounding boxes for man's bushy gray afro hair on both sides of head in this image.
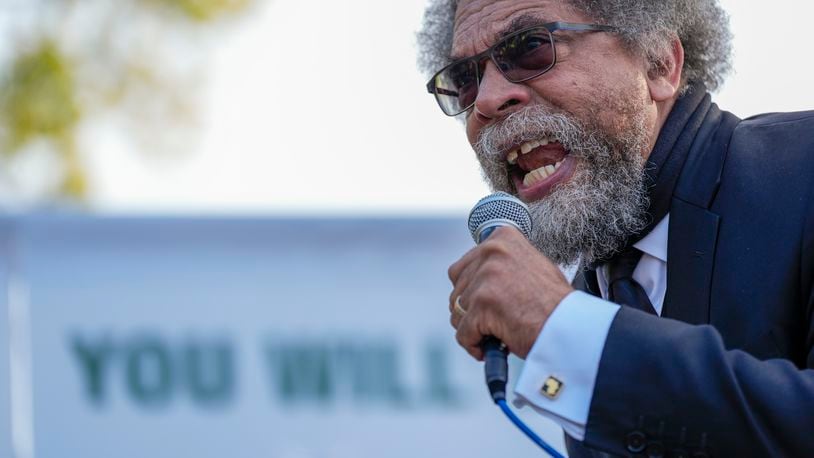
[417,0,732,91]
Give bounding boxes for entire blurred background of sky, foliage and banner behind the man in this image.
[0,0,814,458]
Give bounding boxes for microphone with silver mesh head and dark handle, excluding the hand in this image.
[468,192,531,404]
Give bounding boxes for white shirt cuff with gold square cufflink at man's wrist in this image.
[514,291,619,441]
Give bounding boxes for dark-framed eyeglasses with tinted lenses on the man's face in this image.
[427,22,617,116]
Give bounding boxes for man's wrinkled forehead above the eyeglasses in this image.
[452,0,587,57]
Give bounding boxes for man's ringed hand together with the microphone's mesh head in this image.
[449,193,573,360]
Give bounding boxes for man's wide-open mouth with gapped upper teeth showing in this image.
[506,136,576,202]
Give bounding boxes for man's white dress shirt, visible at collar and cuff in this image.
[514,215,670,441]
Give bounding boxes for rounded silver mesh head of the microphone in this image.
[469,192,531,243]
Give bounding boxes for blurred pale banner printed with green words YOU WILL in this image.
[0,216,562,458]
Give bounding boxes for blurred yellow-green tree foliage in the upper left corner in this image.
[0,0,260,201]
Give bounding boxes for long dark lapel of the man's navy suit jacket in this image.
[662,106,740,324]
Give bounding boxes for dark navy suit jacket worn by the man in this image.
[567,105,814,457]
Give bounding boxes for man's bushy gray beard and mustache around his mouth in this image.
[474,106,649,266]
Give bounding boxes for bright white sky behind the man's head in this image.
[86,0,814,216]
